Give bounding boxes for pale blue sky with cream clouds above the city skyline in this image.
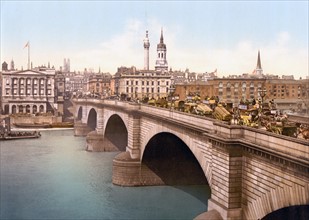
[0,0,309,79]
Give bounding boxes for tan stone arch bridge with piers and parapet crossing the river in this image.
[74,99,309,219]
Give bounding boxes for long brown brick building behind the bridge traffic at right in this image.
[175,77,309,112]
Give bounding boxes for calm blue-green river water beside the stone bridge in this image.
[0,130,210,220]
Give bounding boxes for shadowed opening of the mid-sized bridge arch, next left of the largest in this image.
[104,114,128,151]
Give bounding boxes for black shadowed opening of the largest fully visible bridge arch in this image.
[142,132,208,185]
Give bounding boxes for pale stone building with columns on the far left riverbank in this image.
[1,69,55,114]
